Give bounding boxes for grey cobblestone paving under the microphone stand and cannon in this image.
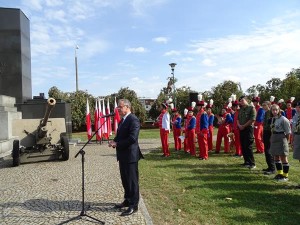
[0,139,160,225]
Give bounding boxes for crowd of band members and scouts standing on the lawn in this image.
[158,93,300,181]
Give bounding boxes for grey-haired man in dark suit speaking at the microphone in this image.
[109,99,143,216]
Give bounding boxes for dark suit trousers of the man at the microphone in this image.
[119,161,140,207]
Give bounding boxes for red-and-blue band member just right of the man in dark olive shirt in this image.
[252,94,265,154]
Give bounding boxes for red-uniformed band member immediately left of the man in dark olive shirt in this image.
[232,100,242,157]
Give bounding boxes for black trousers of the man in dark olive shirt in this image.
[240,126,255,165]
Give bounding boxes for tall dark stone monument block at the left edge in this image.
[0,8,32,103]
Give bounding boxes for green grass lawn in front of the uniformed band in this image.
[139,130,300,225]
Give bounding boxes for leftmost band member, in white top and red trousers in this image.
[158,103,170,157]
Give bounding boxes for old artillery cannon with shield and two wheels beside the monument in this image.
[12,98,69,166]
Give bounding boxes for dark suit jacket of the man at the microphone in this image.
[114,113,143,163]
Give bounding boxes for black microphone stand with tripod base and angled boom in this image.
[59,114,113,225]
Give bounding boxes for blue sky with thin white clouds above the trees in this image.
[0,0,300,98]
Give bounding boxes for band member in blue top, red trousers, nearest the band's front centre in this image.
[196,100,208,160]
